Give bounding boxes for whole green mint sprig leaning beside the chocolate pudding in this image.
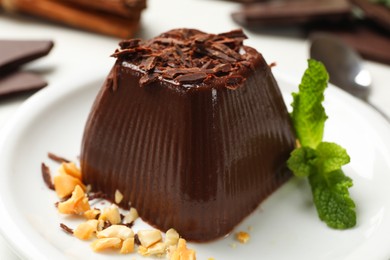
[287,59,356,229]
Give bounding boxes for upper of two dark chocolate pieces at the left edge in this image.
[0,40,53,73]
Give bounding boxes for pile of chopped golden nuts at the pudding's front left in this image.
[41,154,196,260]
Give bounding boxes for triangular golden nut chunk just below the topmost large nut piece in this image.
[58,185,90,214]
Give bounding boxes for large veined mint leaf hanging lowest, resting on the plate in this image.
[309,170,356,229]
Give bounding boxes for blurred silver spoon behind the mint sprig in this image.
[310,33,390,121]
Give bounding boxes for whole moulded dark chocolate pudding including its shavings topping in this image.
[81,29,295,241]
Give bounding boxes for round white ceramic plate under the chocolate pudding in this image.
[0,73,390,260]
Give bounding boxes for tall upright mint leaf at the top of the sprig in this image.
[291,59,329,148]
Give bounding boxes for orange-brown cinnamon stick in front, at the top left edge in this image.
[0,0,140,38]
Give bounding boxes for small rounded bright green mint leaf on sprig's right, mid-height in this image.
[315,142,350,174]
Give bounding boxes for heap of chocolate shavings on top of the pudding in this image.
[111,29,259,89]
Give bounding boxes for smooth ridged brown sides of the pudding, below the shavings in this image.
[81,52,295,241]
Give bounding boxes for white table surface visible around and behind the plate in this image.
[0,0,390,259]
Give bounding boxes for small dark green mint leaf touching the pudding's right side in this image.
[287,147,316,177]
